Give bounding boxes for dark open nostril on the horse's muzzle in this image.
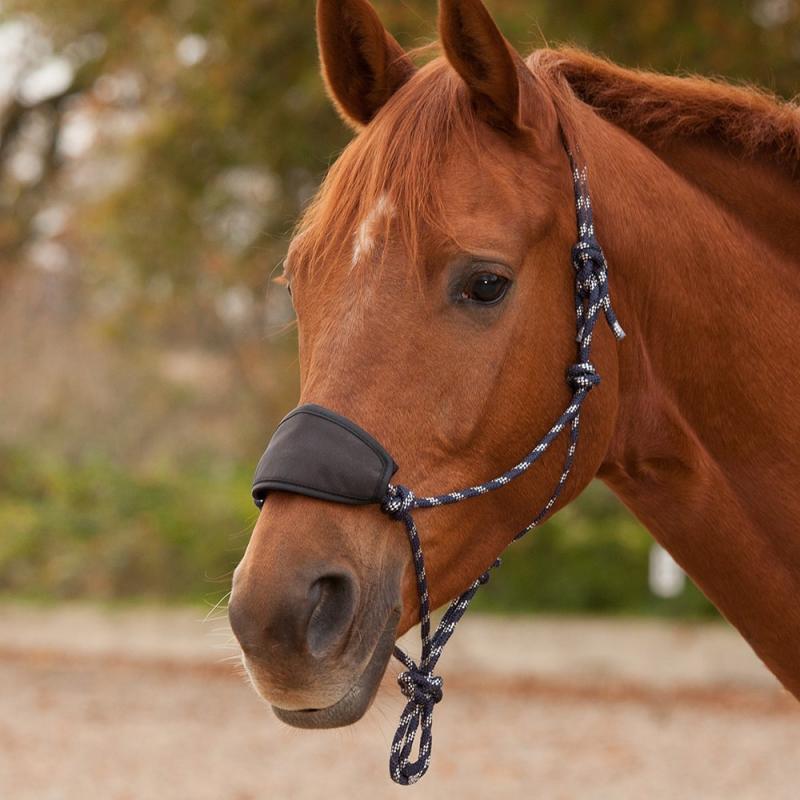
[306,574,356,658]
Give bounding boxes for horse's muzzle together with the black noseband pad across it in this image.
[229,405,407,728]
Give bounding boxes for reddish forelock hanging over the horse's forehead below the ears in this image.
[293,58,506,288]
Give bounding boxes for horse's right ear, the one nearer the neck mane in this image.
[439,0,527,131]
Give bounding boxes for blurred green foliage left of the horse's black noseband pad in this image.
[0,448,255,599]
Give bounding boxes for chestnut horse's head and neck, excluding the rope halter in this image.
[230,0,800,748]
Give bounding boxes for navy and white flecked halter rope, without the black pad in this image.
[381,153,625,786]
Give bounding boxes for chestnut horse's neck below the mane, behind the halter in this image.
[583,109,800,697]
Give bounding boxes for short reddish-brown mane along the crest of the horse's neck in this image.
[528,48,800,174]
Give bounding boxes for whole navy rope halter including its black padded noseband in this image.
[253,153,625,785]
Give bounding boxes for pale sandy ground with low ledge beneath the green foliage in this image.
[0,606,800,800]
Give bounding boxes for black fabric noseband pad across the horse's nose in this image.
[253,403,397,508]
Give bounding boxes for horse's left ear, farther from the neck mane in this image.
[317,0,414,129]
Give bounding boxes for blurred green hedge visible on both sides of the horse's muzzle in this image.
[0,440,715,616]
